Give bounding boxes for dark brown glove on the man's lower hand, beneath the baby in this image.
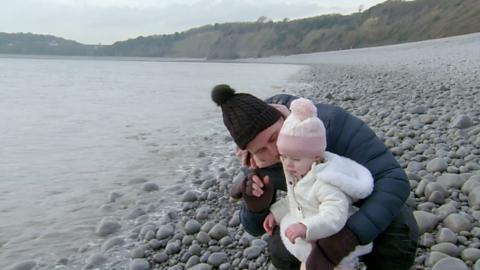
[306,226,360,270]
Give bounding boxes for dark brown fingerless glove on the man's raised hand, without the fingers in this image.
[230,168,273,213]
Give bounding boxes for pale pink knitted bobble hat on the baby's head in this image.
[277,98,327,157]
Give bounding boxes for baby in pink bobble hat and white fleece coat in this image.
[263,98,373,269]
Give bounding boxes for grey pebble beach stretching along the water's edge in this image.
[6,34,480,270]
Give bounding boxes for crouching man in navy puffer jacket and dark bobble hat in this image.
[212,85,419,270]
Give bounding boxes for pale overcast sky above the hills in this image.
[0,0,385,45]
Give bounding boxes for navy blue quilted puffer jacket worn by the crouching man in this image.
[240,94,410,245]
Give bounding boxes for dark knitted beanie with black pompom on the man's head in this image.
[212,84,282,150]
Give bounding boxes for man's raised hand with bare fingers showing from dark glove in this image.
[230,158,274,213]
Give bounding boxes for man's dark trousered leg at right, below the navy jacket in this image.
[363,206,419,270]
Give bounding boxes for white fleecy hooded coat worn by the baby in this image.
[270,152,374,266]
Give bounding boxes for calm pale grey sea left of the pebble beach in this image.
[0,58,303,269]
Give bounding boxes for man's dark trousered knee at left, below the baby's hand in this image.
[268,226,300,270]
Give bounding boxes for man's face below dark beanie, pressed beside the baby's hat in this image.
[247,118,284,162]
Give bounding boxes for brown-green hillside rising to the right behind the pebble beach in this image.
[96,0,480,59]
